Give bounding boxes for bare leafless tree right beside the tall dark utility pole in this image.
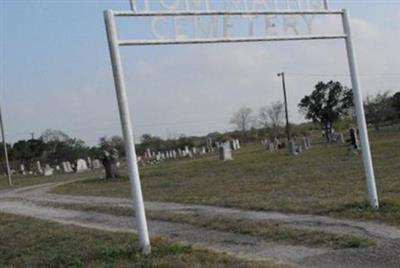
[258,102,284,137]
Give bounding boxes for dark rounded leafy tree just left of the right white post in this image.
[298,81,353,142]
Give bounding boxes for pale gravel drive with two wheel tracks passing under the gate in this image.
[0,182,400,268]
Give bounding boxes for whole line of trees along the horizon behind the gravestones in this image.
[0,81,400,172]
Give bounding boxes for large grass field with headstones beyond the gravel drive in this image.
[56,131,400,225]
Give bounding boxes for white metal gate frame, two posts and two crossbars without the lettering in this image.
[104,1,379,254]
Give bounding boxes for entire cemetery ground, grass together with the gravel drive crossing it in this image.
[0,130,400,267]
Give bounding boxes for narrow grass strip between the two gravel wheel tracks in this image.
[33,202,376,249]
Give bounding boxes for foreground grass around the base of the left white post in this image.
[0,214,283,267]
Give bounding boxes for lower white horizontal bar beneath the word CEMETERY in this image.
[118,34,347,46]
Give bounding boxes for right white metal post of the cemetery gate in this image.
[342,9,379,208]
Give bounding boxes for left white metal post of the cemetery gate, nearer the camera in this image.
[104,10,151,254]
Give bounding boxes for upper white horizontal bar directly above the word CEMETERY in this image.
[112,10,343,17]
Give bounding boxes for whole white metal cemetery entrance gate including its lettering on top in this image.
[104,0,379,254]
